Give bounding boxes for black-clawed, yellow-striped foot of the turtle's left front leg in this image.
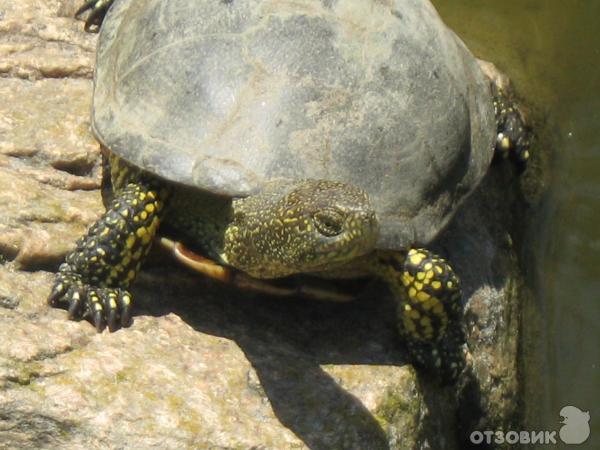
[48,264,131,332]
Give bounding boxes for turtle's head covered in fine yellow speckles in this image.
[222,180,378,278]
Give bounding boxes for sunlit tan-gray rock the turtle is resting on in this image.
[0,0,521,449]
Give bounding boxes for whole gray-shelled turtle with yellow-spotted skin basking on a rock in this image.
[48,0,528,379]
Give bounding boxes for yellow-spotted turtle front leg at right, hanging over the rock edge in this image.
[377,249,465,382]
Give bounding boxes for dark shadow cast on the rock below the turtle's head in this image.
[136,270,406,450]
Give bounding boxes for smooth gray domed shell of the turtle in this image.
[92,0,495,249]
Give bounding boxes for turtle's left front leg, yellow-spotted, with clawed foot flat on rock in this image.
[48,183,166,331]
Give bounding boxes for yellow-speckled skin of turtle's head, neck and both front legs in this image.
[49,155,463,379]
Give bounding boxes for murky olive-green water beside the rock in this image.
[434,0,600,449]
